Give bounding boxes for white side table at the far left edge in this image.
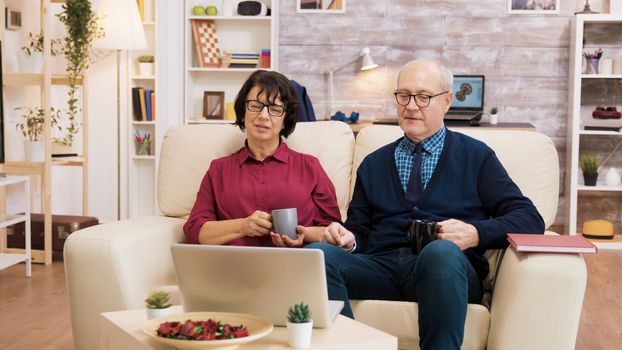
[0,176,32,277]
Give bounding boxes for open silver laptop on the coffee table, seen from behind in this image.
[171,244,343,328]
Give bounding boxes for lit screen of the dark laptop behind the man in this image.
[449,75,484,111]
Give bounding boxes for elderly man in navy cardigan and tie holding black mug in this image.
[307,60,544,349]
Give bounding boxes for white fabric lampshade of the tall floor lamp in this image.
[93,0,147,50]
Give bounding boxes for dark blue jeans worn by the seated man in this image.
[306,240,483,349]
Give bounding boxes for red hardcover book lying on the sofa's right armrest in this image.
[508,233,596,253]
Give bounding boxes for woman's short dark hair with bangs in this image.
[234,70,300,137]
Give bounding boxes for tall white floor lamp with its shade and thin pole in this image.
[93,0,147,220]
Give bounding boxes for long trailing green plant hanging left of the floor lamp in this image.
[56,0,104,146]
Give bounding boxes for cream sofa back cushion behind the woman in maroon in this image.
[158,121,354,218]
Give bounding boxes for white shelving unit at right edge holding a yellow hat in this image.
[565,14,622,235]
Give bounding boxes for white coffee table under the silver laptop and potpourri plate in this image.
[100,306,397,350]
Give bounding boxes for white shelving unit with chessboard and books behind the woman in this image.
[184,0,279,124]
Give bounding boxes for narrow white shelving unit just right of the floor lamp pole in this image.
[127,0,161,218]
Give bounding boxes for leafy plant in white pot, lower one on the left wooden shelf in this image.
[15,107,62,162]
